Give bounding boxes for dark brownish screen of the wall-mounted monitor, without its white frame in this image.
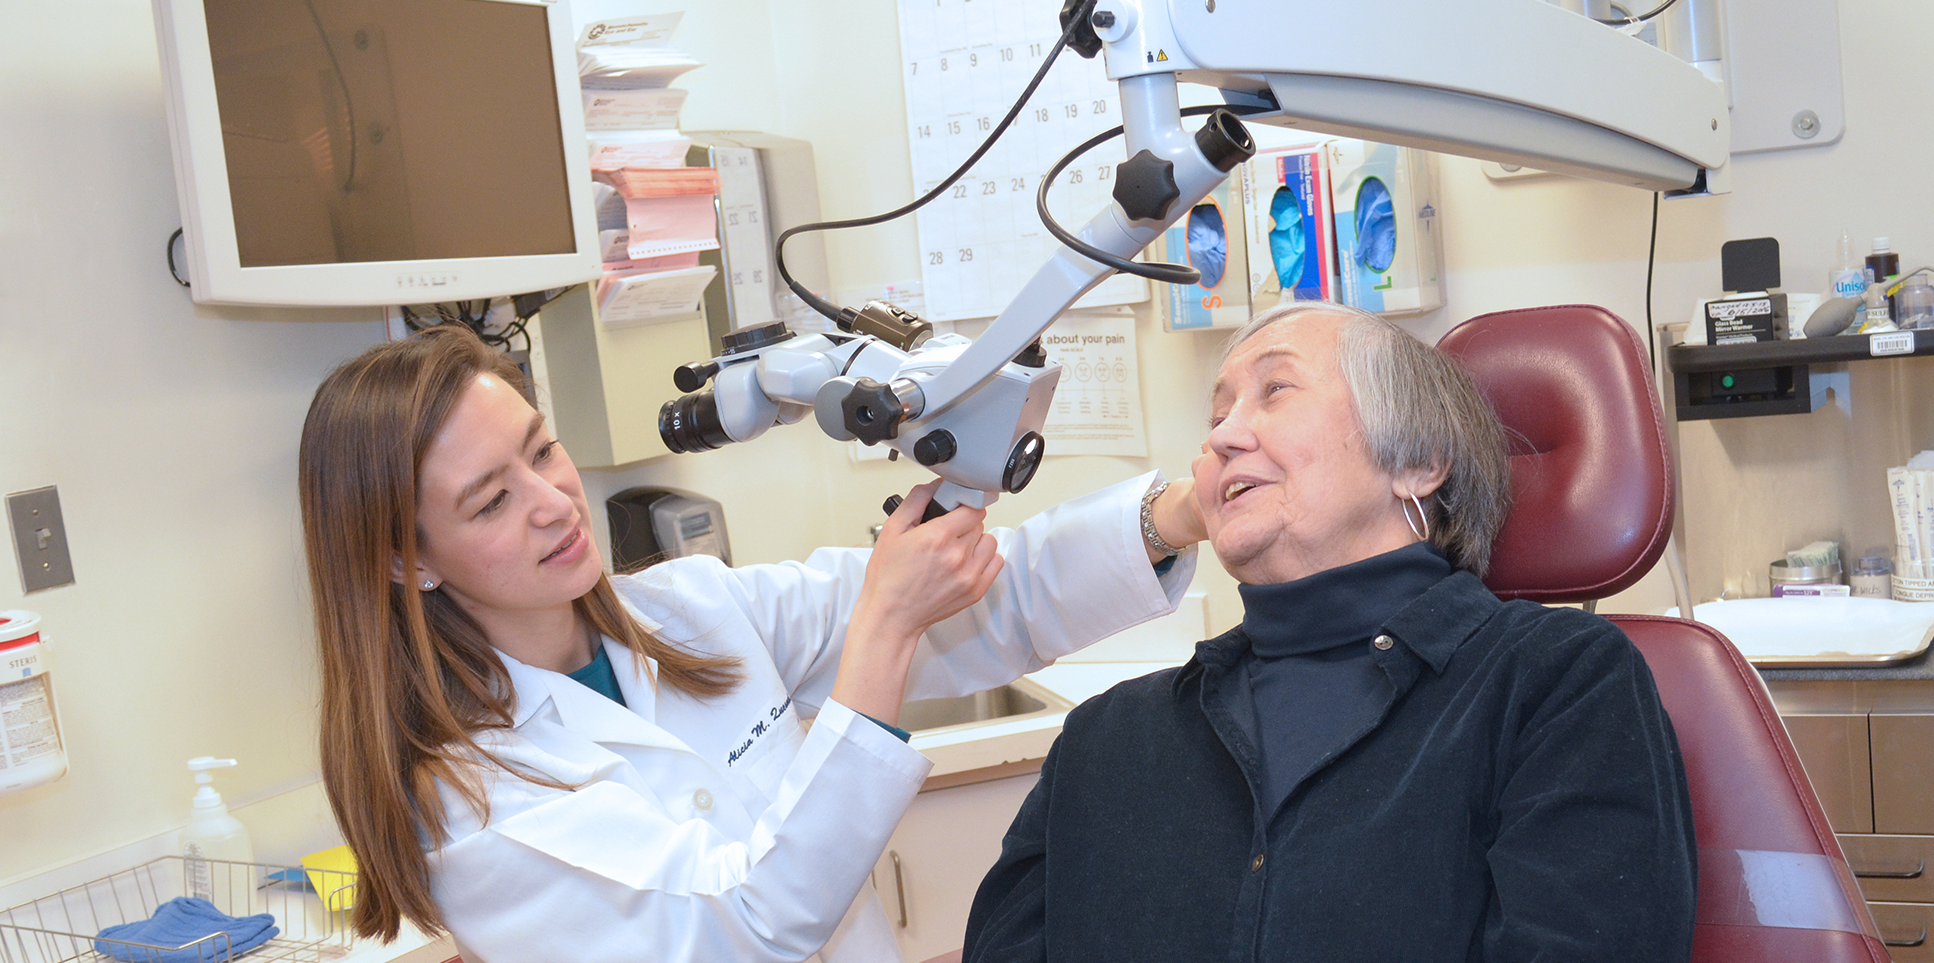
[203,0,576,269]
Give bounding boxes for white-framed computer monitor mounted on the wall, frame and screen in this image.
[155,0,600,306]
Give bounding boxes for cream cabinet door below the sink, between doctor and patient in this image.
[872,773,1039,963]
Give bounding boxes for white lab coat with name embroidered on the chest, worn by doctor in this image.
[429,476,1195,963]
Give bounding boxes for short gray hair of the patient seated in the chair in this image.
[1216,302,1510,576]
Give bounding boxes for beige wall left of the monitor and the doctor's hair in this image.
[0,0,383,882]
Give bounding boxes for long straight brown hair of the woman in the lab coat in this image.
[298,327,739,942]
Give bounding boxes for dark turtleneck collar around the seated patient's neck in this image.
[1236,541,1451,659]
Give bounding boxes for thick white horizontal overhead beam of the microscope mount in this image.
[1152,0,1731,191]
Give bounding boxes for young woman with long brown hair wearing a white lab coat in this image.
[300,327,1201,963]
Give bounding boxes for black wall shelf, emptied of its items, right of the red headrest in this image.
[1665,331,1934,422]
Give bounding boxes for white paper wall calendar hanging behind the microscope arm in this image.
[899,0,1149,321]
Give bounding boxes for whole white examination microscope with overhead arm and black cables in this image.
[659,0,1731,516]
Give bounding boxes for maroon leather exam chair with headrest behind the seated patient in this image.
[1439,306,1888,963]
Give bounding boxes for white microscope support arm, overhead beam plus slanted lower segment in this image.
[923,0,1731,418]
